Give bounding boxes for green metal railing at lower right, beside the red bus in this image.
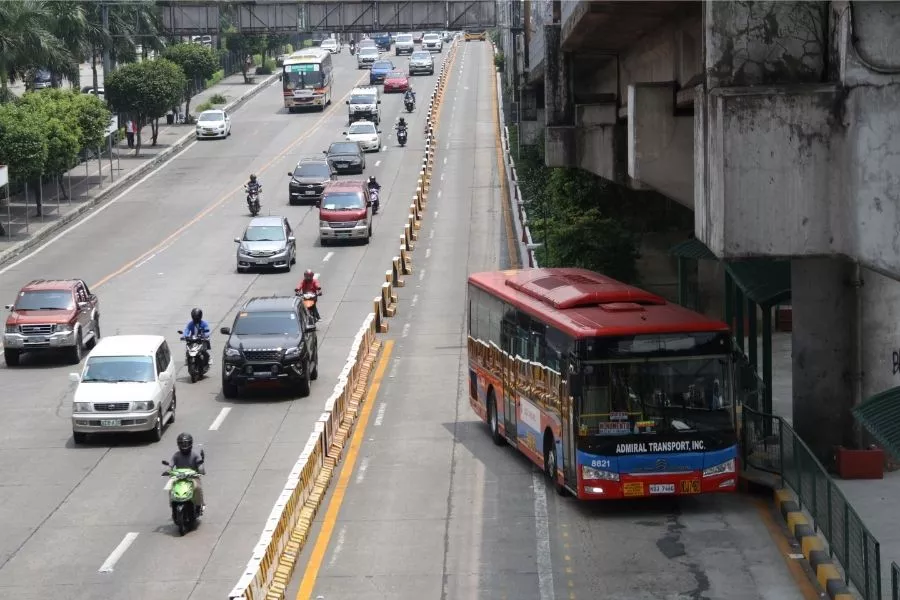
[741,404,884,600]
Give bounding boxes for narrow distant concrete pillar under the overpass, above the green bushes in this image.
[544,23,577,167]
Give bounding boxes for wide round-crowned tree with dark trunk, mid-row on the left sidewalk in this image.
[104,58,187,156]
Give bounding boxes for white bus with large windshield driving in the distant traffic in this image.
[281,48,333,112]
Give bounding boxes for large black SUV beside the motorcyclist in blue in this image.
[221,296,319,398]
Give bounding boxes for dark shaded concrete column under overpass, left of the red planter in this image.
[791,258,856,465]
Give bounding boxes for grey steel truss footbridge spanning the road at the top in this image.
[157,0,500,36]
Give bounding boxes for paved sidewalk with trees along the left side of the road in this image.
[0,73,278,264]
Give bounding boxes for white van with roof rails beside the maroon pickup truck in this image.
[69,335,175,444]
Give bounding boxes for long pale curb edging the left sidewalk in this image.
[0,73,278,265]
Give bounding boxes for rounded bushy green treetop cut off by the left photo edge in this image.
[0,104,48,182]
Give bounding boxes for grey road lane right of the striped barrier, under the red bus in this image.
[287,42,809,600]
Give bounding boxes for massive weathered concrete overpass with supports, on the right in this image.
[507,1,900,460]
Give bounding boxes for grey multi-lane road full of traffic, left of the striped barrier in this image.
[0,52,446,600]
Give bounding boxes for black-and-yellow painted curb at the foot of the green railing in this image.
[775,488,856,600]
